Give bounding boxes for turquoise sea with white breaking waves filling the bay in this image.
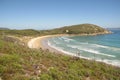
[48,30,120,67]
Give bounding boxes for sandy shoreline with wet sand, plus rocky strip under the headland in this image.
[27,32,112,55]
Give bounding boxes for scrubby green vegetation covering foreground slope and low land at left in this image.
[0,24,120,80]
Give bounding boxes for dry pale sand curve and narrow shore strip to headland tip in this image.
[27,32,112,51]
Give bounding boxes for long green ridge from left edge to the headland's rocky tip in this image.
[0,24,110,36]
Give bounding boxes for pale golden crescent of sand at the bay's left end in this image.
[27,34,68,53]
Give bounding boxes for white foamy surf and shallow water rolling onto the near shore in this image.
[47,30,120,67]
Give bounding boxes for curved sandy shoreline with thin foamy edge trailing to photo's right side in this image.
[28,34,119,67]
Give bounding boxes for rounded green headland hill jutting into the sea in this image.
[47,24,110,34]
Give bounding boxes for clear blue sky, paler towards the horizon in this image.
[0,0,120,30]
